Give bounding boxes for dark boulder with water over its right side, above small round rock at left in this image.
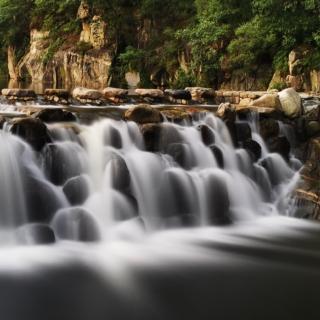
[42,143,84,185]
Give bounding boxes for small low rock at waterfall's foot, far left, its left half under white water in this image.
[16,223,56,245]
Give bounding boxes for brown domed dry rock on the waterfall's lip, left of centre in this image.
[125,104,163,124]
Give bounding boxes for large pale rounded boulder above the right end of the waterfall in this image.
[279,88,302,118]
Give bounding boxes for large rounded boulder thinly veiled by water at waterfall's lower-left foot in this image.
[52,207,100,242]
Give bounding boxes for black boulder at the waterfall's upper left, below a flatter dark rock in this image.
[10,118,51,151]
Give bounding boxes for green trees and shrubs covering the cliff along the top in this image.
[0,0,320,87]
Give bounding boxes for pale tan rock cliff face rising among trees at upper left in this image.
[19,3,112,89]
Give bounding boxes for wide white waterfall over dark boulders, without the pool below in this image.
[0,113,299,241]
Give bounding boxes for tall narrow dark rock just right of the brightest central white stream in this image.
[108,156,131,192]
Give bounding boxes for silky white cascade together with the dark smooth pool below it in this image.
[0,108,320,320]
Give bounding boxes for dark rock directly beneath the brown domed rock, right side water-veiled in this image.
[141,124,182,152]
